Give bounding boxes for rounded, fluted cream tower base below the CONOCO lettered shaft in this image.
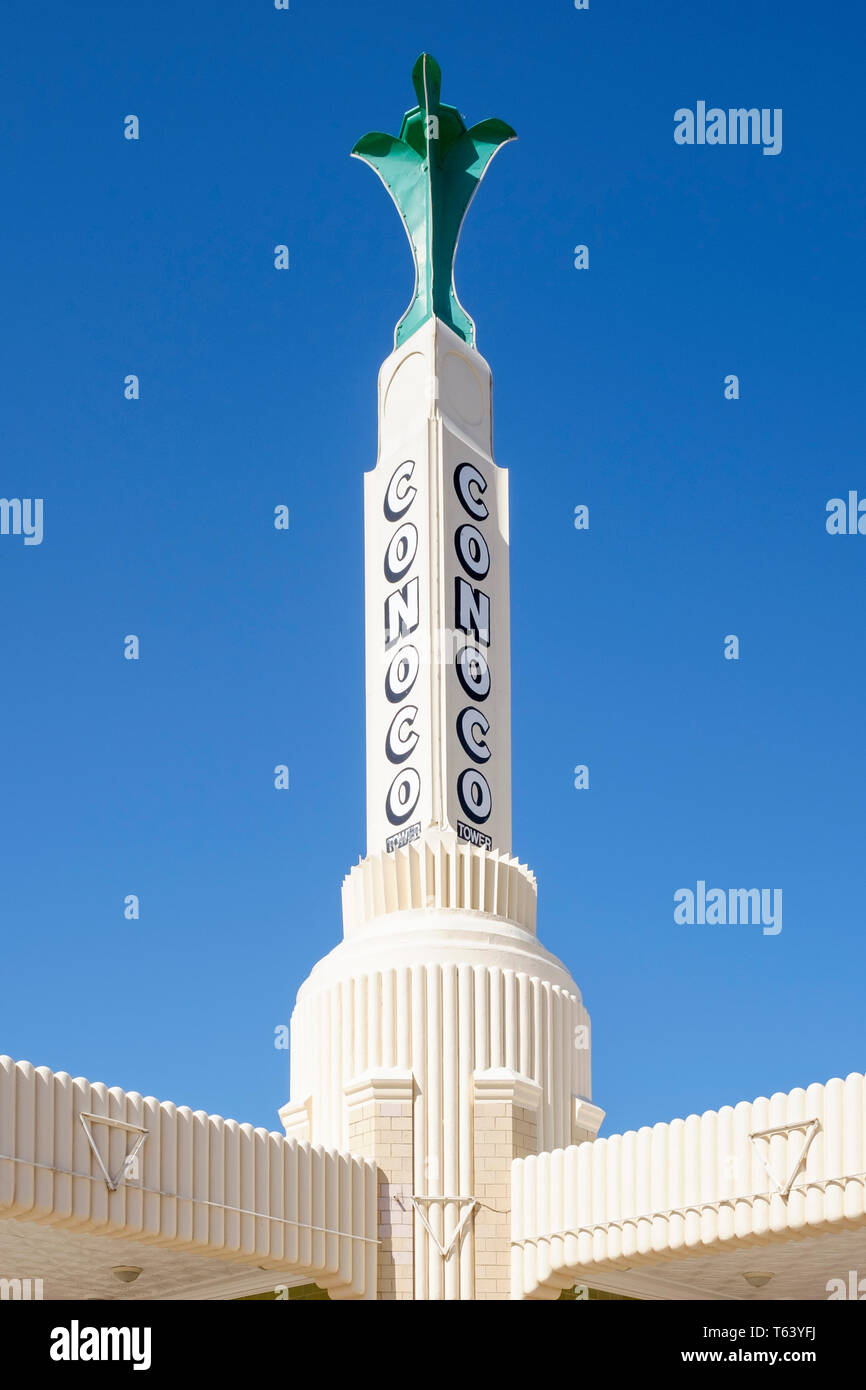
[281,833,601,1298]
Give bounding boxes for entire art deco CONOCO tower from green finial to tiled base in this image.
[281,54,602,1300]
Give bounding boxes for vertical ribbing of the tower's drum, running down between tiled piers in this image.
[292,942,589,1300]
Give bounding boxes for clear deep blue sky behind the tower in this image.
[0,0,866,1133]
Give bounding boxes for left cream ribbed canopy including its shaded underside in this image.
[0,1056,377,1298]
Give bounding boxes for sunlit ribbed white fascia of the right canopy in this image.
[512,1072,866,1298]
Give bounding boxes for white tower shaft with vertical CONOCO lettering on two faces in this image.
[364,318,512,853]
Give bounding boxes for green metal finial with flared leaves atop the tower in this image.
[352,53,516,348]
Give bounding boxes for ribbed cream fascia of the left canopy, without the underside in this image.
[0,1056,377,1298]
